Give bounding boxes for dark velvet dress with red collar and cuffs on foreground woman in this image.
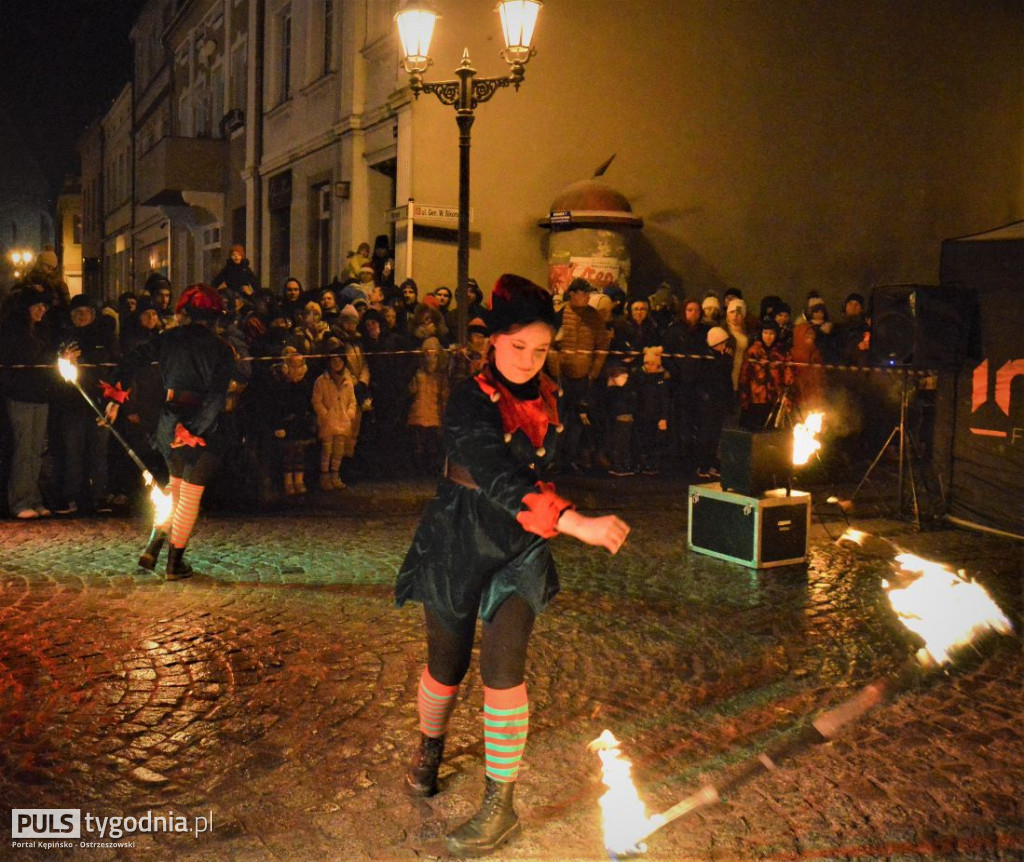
[395,364,571,629]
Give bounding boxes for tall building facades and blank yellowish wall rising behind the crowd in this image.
[79,0,1024,307]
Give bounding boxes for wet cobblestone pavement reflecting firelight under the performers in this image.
[0,479,1024,861]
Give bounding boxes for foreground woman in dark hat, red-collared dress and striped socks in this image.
[395,275,630,856]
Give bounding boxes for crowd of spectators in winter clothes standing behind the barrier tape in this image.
[0,236,868,519]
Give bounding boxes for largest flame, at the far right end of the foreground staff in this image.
[885,554,1013,664]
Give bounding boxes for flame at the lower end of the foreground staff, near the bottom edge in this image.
[587,730,663,856]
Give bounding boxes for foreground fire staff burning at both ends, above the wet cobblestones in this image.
[589,528,1013,859]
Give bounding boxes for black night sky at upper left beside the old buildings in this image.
[0,0,145,199]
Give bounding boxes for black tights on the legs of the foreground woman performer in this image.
[424,596,536,688]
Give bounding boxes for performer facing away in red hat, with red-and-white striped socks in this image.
[106,285,234,580]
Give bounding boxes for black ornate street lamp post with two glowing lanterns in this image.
[395,0,544,344]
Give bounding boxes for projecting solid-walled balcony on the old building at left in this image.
[138,137,227,207]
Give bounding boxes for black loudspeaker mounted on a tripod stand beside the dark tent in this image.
[869,285,978,371]
